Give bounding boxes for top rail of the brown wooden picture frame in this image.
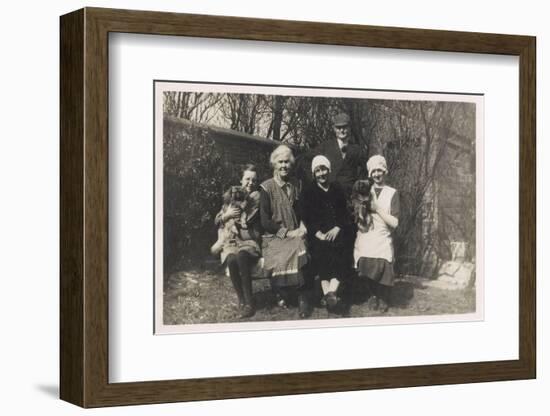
[90,8,529,55]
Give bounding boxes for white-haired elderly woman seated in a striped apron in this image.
[260,145,311,318]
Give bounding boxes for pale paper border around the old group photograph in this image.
[153,79,485,335]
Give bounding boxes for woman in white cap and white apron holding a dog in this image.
[353,155,399,312]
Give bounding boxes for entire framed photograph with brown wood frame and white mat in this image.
[60,8,536,407]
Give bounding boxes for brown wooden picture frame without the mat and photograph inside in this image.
[60,8,536,407]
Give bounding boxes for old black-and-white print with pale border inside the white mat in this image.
[154,81,483,333]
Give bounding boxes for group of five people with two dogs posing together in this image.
[212,114,399,318]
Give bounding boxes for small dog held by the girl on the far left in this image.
[210,186,249,254]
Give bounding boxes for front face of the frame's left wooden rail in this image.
[84,10,109,406]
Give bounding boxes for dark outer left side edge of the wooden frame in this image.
[59,11,85,406]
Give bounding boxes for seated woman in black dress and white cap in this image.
[303,155,351,312]
